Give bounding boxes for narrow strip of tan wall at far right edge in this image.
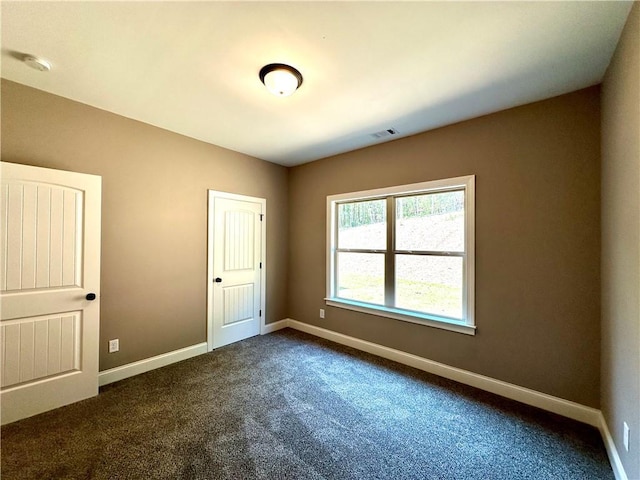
[602,3,640,479]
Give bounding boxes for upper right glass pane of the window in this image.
[396,190,464,252]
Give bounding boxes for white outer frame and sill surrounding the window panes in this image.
[325,175,476,335]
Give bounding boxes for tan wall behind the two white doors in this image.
[1,81,288,370]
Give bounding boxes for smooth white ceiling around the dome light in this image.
[1,1,633,165]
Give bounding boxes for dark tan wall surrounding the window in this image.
[289,87,600,407]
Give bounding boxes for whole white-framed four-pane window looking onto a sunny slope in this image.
[325,175,475,335]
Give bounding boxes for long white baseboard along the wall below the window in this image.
[286,319,601,428]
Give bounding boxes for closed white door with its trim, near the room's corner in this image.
[208,191,266,349]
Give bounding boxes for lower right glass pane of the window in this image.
[396,255,462,319]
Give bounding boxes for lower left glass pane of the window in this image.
[337,252,384,305]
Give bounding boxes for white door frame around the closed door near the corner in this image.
[207,190,267,352]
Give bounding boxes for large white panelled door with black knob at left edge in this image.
[0,162,102,424]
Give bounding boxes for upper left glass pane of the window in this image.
[338,199,387,250]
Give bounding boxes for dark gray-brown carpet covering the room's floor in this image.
[1,330,614,480]
